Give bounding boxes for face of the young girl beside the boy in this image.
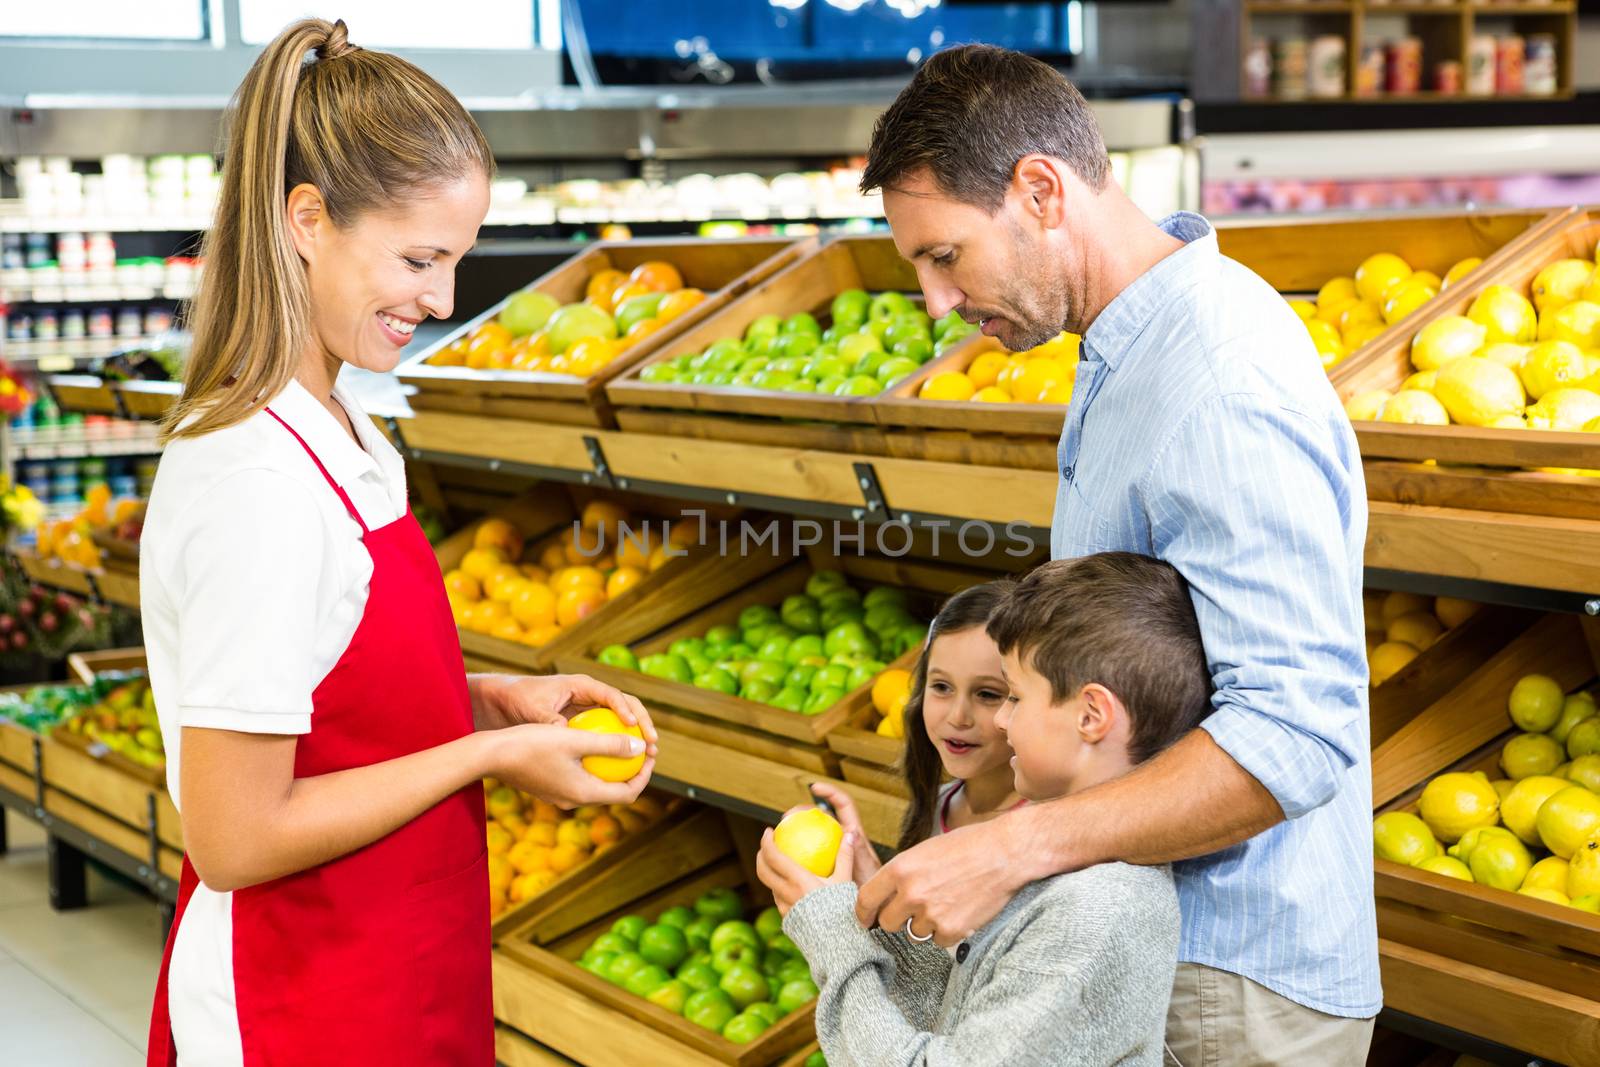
[922,625,1011,779]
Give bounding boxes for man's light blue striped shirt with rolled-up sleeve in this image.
[1051,213,1382,1017]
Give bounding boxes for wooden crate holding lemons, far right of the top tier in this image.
[1333,211,1600,476]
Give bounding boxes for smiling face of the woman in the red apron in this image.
[290,174,490,371]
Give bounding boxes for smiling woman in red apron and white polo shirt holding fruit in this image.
[142,21,654,1067]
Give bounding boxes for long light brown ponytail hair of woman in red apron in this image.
[165,19,494,438]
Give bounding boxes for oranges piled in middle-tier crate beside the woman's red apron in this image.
[445,501,694,648]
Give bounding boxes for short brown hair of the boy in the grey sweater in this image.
[989,552,1211,763]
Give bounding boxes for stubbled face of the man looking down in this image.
[883,171,1074,352]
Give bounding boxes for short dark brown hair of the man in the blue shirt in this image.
[861,45,1110,214]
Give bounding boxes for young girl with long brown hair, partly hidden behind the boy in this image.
[814,579,1026,885]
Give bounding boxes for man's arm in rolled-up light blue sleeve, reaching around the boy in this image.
[858,397,1366,944]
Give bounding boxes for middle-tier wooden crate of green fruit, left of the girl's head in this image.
[557,547,995,774]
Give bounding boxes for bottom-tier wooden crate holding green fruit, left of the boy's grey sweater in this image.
[494,812,816,1067]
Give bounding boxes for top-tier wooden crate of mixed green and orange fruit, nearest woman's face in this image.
[395,237,816,427]
